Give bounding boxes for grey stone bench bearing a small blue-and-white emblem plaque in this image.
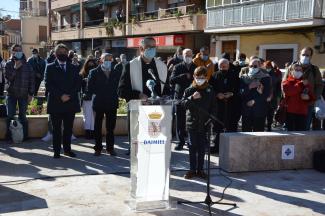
[219,131,325,172]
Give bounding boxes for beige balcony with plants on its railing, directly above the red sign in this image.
[127,5,206,35]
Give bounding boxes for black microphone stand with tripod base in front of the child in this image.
[177,104,237,216]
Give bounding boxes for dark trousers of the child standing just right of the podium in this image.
[188,131,208,171]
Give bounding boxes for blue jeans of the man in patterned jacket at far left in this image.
[6,96,28,138]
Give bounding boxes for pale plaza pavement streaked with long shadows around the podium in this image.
[0,137,325,216]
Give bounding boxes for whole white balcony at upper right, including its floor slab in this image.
[205,0,325,33]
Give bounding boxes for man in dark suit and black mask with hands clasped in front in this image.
[45,44,81,158]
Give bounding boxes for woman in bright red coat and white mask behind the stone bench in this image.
[282,63,315,131]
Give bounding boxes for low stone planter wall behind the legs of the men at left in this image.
[0,115,128,139]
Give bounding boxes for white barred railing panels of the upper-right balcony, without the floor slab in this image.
[207,0,325,28]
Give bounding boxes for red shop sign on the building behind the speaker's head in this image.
[128,35,185,47]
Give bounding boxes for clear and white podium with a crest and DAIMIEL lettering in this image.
[128,100,173,211]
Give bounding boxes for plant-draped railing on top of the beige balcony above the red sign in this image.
[131,4,204,21]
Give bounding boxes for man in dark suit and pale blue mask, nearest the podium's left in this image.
[88,53,123,156]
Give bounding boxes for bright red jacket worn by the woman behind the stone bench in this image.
[282,76,315,115]
